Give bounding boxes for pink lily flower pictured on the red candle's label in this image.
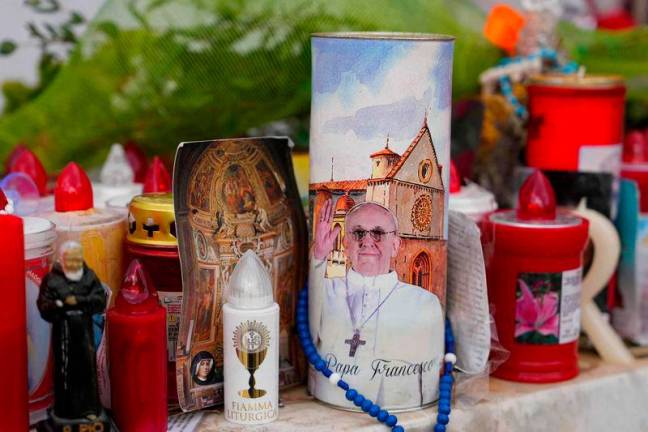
[515,279,559,337]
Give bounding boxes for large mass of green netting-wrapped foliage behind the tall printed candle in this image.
[0,0,499,168]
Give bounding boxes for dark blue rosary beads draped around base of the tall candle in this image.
[296,289,456,432]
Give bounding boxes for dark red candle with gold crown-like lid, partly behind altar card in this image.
[126,193,182,403]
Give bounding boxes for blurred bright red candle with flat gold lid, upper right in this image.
[526,74,626,176]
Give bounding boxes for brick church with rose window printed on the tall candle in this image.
[310,118,446,304]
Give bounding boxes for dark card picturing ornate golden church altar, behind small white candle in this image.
[173,138,307,411]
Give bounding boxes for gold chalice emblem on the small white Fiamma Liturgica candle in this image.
[232,321,270,399]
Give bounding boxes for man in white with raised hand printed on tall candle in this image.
[309,199,444,409]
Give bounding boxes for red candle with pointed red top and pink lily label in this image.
[484,171,589,382]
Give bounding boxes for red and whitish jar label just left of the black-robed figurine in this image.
[25,252,54,424]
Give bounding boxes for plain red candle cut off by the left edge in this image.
[0,208,29,432]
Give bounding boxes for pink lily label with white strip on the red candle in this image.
[515,268,582,345]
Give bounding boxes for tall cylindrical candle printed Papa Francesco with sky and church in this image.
[309,33,454,410]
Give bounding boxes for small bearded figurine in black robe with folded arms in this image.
[38,241,110,432]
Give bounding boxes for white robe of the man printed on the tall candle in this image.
[308,257,444,410]
